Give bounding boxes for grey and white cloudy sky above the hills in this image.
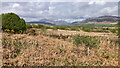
[0,1,118,21]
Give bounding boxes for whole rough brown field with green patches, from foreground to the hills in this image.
[2,24,119,66]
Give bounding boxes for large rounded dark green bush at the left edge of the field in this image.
[2,13,26,32]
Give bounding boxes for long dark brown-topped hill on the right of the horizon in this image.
[72,16,120,24]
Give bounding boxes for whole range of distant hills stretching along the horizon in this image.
[27,16,120,25]
